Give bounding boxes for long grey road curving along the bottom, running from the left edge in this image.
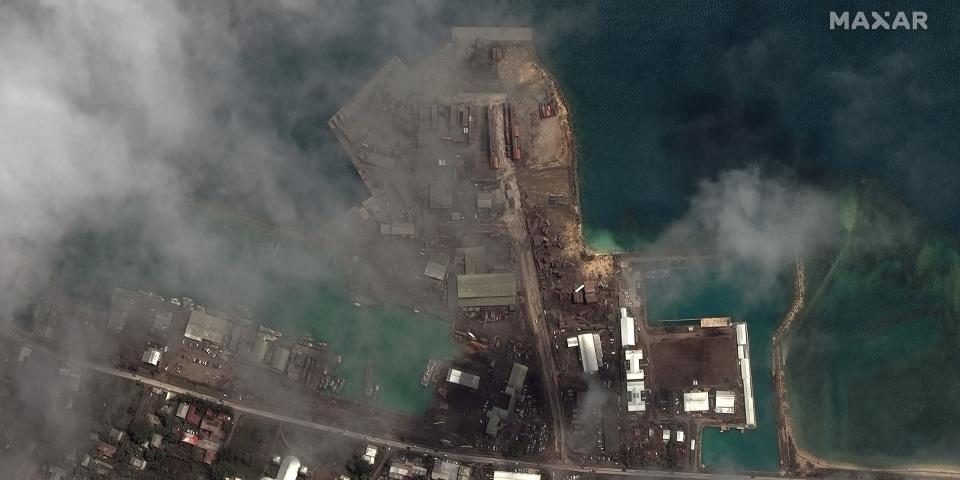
[0,325,800,480]
